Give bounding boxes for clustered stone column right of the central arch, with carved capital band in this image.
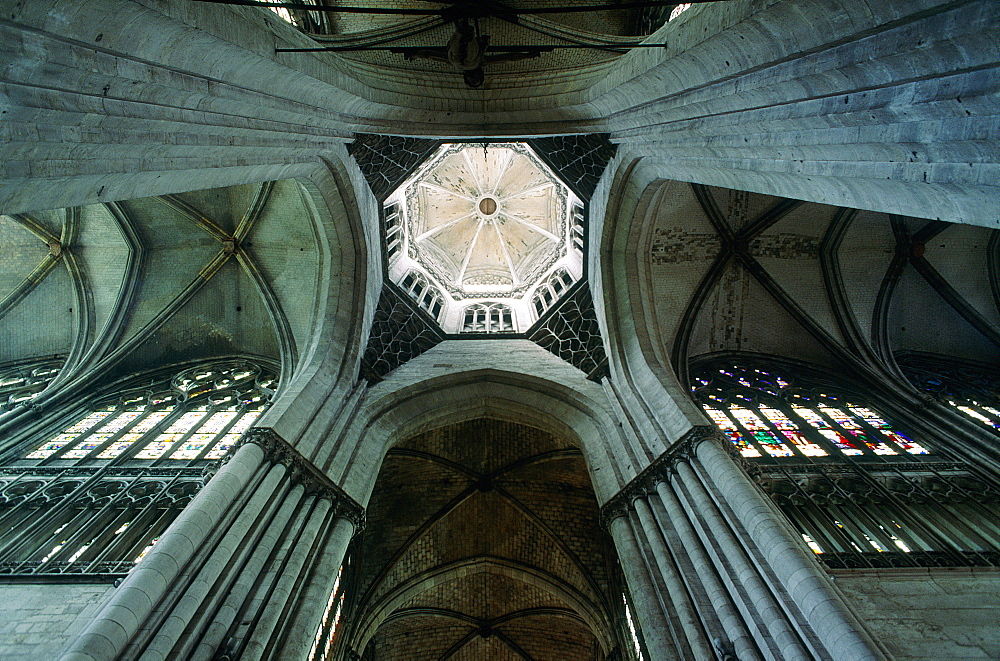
[604,427,883,661]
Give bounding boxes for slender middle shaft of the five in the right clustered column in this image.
[656,481,760,659]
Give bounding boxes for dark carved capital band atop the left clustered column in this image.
[216,427,365,534]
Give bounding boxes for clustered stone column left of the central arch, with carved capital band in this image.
[63,428,364,661]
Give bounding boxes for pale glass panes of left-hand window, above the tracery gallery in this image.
[24,362,276,463]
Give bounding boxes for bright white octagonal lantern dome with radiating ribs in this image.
[385,142,583,333]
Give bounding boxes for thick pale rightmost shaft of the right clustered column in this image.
[694,437,884,661]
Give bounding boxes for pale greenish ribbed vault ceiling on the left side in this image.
[0,181,320,386]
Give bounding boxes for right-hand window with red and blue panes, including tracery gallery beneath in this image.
[692,361,1000,568]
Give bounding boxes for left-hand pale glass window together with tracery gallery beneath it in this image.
[0,360,277,577]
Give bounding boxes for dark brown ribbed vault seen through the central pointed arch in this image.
[347,419,617,660]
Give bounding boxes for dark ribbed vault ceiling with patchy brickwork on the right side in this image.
[639,182,1000,384]
